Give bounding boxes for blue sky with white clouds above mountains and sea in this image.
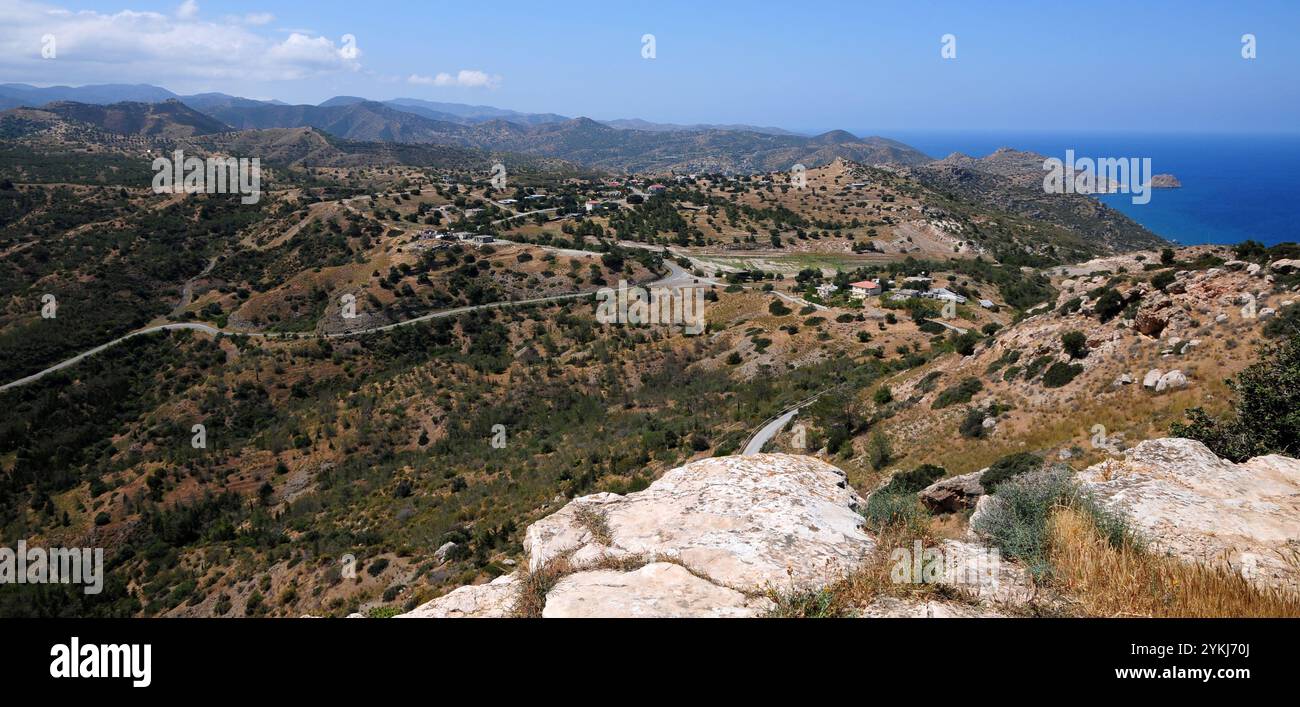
[0,0,1300,133]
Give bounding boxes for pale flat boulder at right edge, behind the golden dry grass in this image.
[1079,438,1300,586]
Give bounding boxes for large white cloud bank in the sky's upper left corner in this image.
[0,0,361,86]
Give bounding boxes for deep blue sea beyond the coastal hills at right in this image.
[855,130,1300,246]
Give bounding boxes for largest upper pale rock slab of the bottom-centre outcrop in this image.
[524,454,872,591]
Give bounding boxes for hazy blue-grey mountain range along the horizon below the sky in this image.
[0,83,930,173]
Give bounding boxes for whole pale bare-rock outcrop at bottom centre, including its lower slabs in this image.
[404,454,874,617]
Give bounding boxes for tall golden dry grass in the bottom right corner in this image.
[1048,508,1300,619]
